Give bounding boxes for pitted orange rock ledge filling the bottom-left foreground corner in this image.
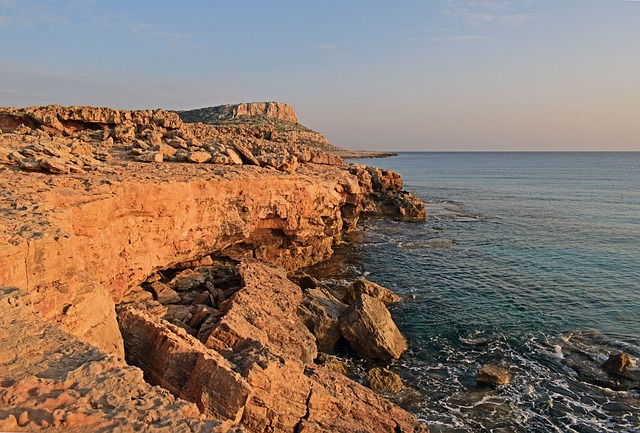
[0,289,238,433]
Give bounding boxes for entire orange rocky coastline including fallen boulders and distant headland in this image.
[0,103,426,433]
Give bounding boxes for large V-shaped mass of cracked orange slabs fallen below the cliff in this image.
[118,262,424,433]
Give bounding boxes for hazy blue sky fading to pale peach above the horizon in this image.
[0,0,640,151]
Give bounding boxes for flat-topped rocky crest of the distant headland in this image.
[178,102,298,123]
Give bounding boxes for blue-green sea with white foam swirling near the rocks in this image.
[308,152,640,433]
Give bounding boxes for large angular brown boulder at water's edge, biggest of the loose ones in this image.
[339,294,407,360]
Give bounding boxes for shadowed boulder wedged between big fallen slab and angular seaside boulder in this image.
[298,287,347,352]
